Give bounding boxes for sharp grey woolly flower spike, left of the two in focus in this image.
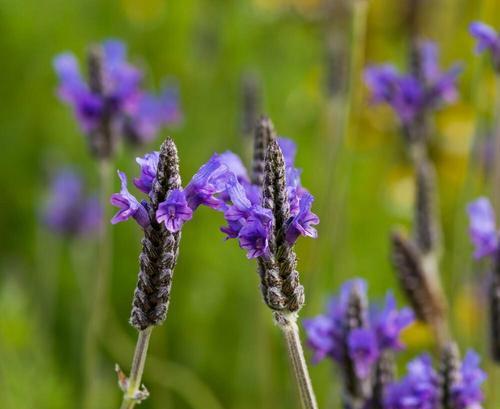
[130,139,181,330]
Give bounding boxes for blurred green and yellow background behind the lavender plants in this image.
[0,0,500,409]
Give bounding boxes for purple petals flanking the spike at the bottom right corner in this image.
[384,350,486,409]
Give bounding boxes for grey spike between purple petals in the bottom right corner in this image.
[440,342,461,409]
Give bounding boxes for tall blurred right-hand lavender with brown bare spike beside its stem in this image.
[365,42,461,345]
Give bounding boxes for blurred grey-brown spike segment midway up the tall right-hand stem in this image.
[414,160,439,254]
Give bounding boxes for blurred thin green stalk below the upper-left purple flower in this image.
[83,159,112,409]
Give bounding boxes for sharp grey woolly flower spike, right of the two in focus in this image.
[262,140,304,312]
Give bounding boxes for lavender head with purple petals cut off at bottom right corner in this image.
[384,343,486,409]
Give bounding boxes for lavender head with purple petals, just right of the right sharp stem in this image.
[304,279,413,409]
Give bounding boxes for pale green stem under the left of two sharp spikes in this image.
[120,327,153,409]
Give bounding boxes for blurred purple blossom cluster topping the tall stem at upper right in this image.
[365,42,461,126]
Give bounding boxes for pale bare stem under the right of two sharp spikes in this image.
[276,314,318,409]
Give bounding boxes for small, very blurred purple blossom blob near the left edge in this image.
[43,169,103,236]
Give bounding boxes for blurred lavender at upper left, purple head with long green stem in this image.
[54,40,180,408]
